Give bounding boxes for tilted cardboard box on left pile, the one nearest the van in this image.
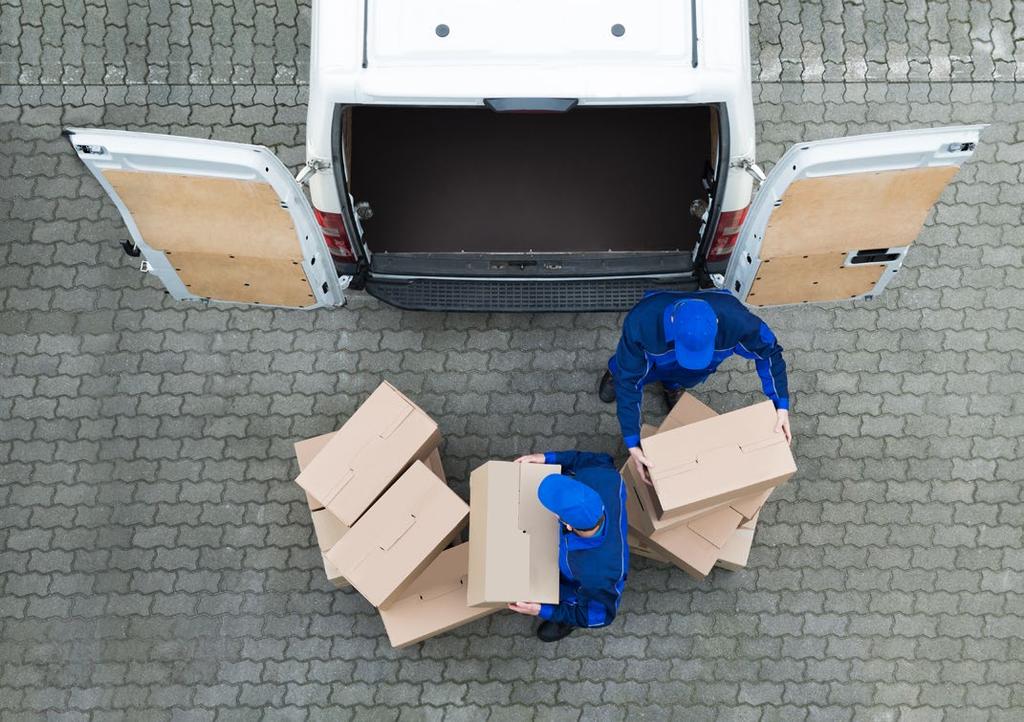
[296,382,440,526]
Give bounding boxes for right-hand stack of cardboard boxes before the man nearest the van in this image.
[622,394,797,580]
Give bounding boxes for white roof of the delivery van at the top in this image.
[310,0,750,104]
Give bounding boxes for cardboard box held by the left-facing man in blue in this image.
[467,461,561,606]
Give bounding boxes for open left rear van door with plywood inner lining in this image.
[65,128,345,308]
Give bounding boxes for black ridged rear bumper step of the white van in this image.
[366,274,697,312]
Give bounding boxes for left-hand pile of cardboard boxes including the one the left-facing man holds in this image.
[295,383,559,647]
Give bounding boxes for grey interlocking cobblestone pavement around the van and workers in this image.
[0,0,1024,720]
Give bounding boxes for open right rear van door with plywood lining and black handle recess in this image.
[725,125,985,306]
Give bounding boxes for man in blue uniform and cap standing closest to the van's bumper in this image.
[598,290,793,483]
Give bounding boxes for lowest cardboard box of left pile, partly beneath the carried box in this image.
[380,542,499,648]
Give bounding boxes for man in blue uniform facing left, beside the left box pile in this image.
[509,452,630,642]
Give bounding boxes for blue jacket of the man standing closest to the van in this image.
[613,291,790,448]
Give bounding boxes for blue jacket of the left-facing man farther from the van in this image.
[541,452,630,627]
